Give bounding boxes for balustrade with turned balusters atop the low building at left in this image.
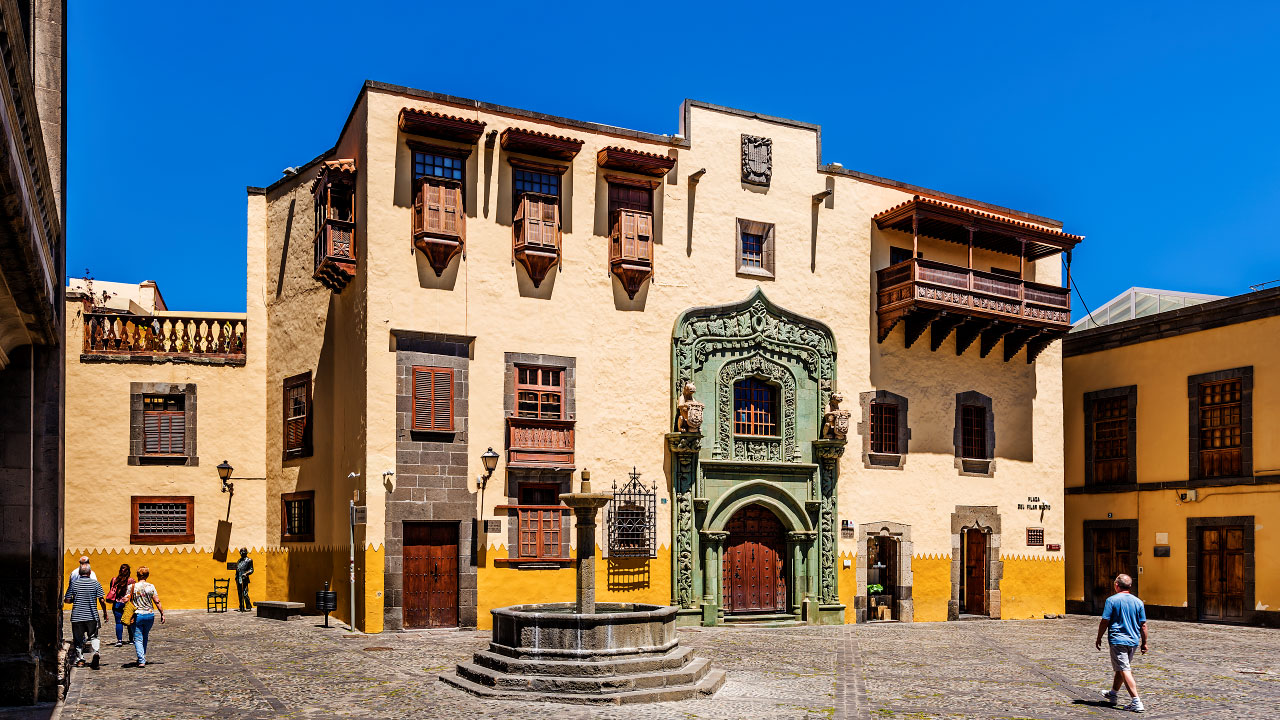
[84,313,248,364]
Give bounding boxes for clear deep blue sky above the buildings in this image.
[67,1,1280,316]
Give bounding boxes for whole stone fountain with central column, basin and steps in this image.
[440,471,724,705]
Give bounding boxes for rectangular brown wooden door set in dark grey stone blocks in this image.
[403,523,458,628]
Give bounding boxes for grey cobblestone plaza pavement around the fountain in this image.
[63,611,1280,720]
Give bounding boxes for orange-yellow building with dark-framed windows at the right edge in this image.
[1064,290,1280,626]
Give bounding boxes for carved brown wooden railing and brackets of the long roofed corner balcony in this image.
[876,259,1071,363]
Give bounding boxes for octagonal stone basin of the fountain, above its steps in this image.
[489,602,677,661]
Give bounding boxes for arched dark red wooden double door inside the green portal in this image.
[722,505,787,612]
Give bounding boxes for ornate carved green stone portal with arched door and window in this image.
[667,288,849,625]
